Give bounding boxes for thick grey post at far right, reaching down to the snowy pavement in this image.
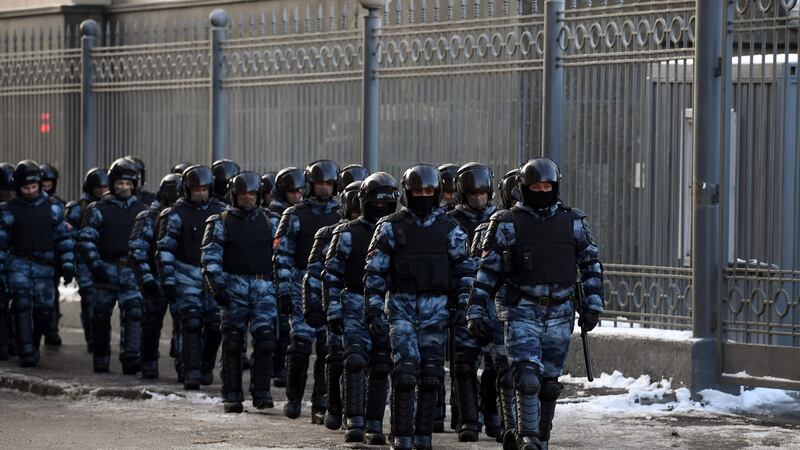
[691,1,730,394]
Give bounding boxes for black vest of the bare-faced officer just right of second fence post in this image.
[222,210,272,279]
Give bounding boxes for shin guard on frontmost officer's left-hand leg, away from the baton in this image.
[514,361,542,450]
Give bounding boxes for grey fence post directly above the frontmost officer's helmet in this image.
[541,0,566,167]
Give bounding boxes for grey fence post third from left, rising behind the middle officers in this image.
[361,0,386,172]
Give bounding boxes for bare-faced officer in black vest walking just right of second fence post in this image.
[201,172,278,413]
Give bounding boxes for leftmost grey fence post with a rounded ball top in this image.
[80,19,100,177]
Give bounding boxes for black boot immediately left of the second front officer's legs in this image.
[364,348,392,445]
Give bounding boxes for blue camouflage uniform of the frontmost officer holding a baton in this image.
[468,203,603,442]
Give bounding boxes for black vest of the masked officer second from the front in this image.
[390,212,454,294]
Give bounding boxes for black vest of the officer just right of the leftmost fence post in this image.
[95,201,147,261]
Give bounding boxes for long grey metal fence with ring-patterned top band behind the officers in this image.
[0,0,800,381]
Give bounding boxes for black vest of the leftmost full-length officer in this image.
[8,198,56,256]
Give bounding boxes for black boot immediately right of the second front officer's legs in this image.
[455,348,479,442]
